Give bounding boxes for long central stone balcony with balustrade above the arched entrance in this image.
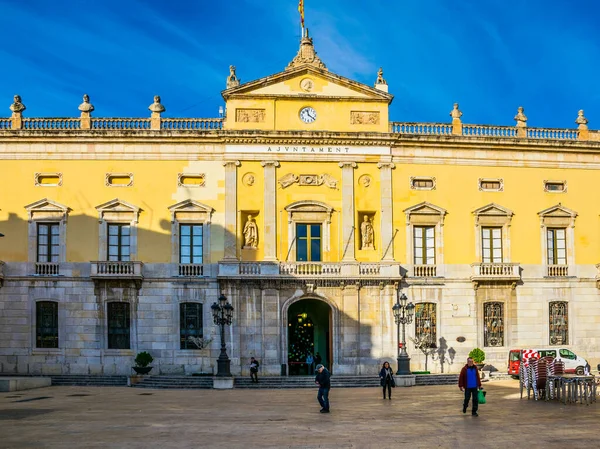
[219,262,401,279]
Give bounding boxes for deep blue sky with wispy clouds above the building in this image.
[0,0,600,129]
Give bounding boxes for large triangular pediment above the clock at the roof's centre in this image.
[222,65,394,103]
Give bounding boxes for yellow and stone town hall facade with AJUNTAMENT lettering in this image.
[0,36,600,375]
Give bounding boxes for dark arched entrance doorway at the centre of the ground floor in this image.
[287,299,333,376]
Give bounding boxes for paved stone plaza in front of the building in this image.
[0,381,600,449]
